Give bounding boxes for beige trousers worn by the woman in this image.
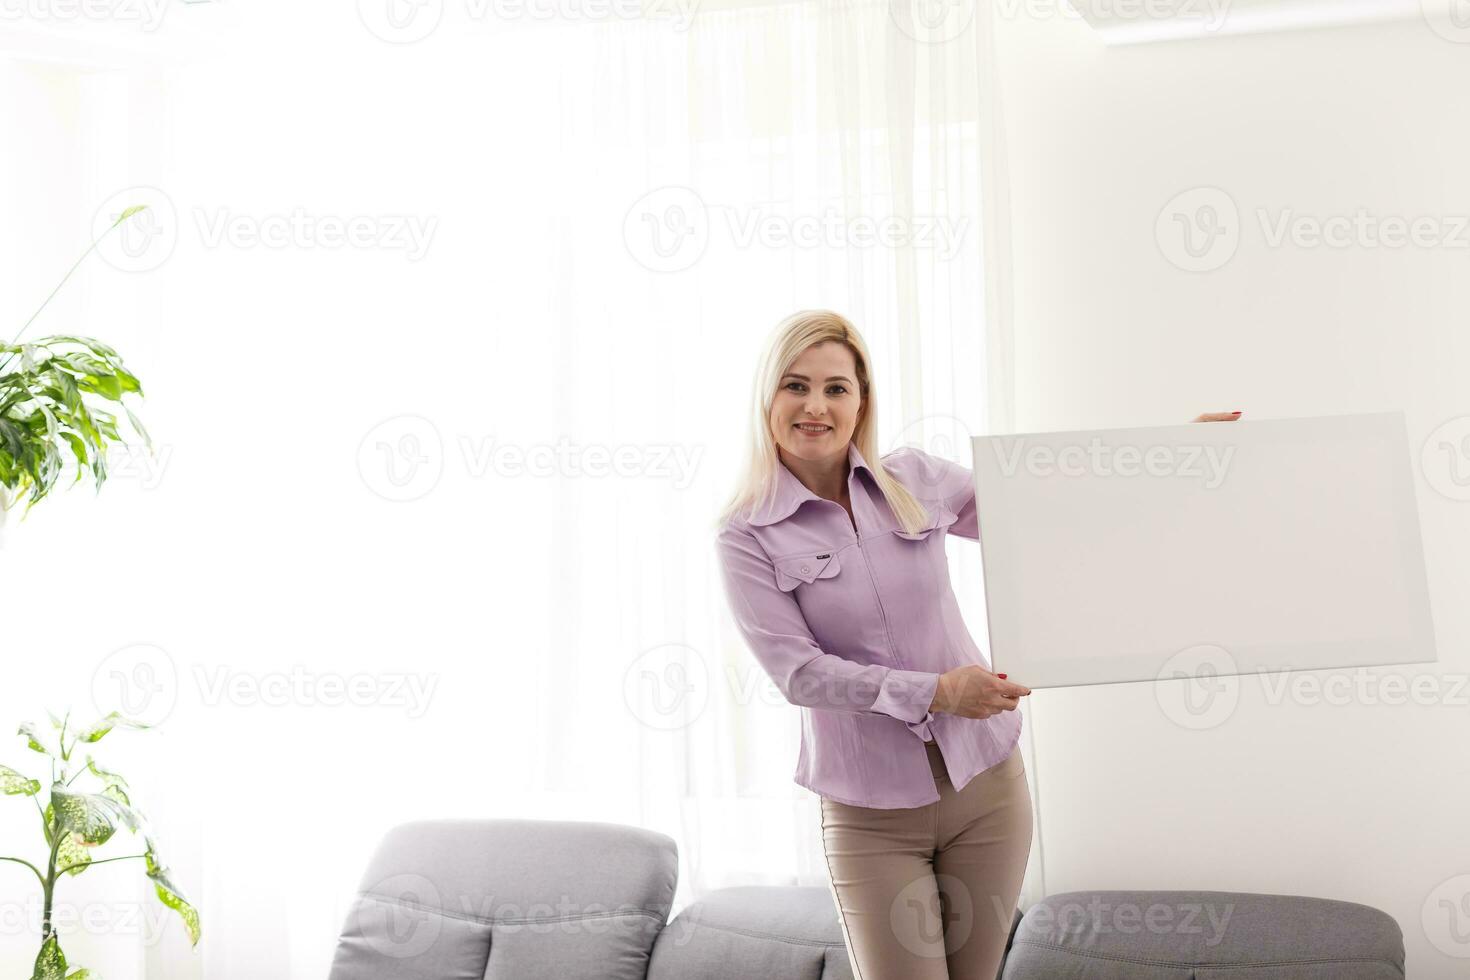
[822,742,1032,980]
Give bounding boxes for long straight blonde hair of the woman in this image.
[717,310,929,533]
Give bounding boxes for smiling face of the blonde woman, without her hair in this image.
[770,341,863,460]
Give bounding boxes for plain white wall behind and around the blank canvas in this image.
[997,4,1470,980]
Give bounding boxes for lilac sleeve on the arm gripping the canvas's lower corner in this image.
[716,527,939,733]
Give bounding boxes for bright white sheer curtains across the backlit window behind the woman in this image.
[0,0,1041,980]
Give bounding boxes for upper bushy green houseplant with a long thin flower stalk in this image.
[0,206,153,526]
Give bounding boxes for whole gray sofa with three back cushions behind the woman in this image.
[331,820,1404,980]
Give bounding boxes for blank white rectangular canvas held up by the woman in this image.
[973,413,1436,688]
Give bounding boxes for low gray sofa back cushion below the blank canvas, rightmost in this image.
[1001,890,1404,980]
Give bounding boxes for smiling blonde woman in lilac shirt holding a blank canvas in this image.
[716,310,1239,980]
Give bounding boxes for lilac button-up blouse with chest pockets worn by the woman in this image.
[716,442,1022,810]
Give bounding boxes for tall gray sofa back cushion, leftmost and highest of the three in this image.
[329,820,678,980]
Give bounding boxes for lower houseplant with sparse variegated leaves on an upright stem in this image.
[0,711,200,980]
